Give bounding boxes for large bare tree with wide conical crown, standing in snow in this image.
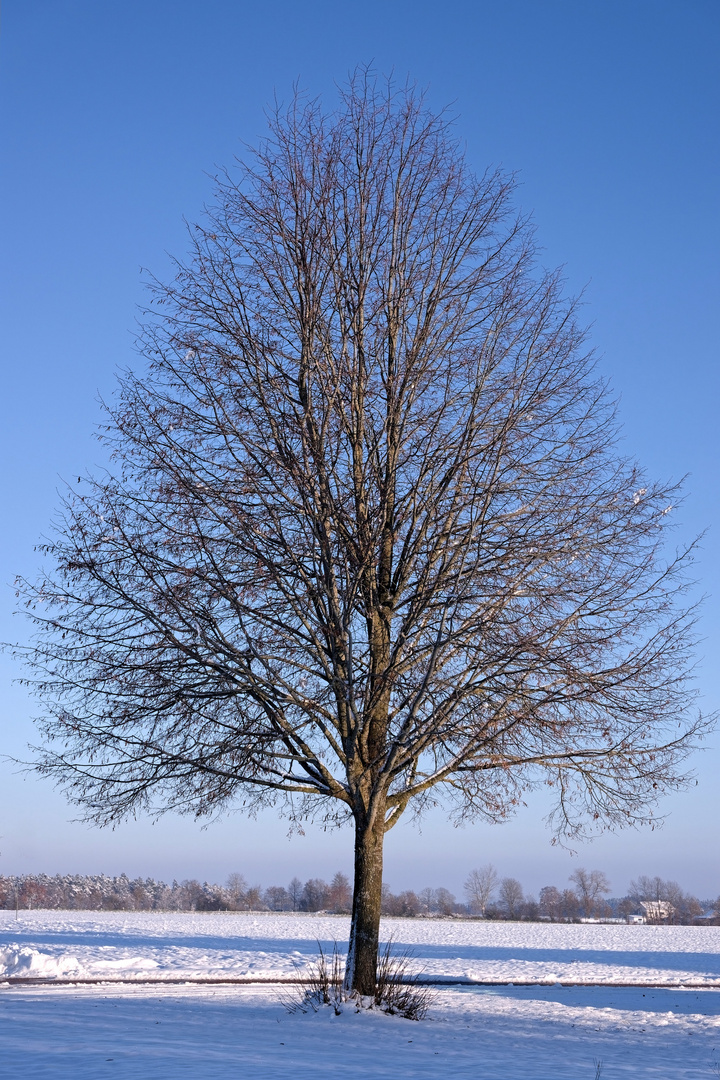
[18,71,702,995]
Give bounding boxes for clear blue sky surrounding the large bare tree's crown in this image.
[0,0,720,896]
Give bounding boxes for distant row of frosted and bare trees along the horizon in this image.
[0,864,720,923]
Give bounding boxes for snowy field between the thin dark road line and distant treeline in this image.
[0,912,720,986]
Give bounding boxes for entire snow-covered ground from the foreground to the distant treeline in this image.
[0,912,720,1080]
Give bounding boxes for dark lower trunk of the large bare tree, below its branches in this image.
[345,814,384,997]
